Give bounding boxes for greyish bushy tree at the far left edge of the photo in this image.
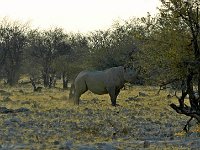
[0,19,28,85]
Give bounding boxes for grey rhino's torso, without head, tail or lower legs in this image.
[75,67,124,94]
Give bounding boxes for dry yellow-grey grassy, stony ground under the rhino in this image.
[0,79,200,150]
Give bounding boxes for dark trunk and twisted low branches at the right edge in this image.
[162,0,200,126]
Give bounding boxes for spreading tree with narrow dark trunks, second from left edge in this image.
[29,28,71,87]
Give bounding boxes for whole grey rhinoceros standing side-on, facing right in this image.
[72,66,138,106]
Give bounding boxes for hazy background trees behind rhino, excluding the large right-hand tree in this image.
[0,18,141,88]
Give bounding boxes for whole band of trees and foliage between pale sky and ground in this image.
[0,0,200,90]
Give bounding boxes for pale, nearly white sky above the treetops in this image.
[0,0,159,33]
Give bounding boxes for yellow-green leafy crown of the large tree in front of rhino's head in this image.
[134,1,196,83]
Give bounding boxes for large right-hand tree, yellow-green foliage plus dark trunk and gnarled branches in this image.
[138,0,200,129]
